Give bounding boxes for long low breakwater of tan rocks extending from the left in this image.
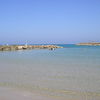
[0,45,63,51]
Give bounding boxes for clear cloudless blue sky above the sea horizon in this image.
[0,0,100,44]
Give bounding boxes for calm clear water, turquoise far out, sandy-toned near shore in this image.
[0,45,100,100]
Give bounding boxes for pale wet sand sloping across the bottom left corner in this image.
[0,87,64,100]
